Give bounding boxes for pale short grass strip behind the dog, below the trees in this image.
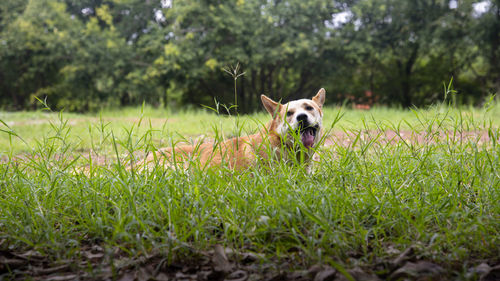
[0,104,500,155]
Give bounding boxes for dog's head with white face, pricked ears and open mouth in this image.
[261,88,325,149]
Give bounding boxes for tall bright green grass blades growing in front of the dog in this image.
[0,97,500,274]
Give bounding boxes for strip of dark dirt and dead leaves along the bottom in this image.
[0,242,500,281]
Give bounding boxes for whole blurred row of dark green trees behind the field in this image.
[0,0,500,112]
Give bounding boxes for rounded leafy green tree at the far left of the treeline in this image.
[0,0,75,108]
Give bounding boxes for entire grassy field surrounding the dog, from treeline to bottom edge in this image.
[0,101,500,280]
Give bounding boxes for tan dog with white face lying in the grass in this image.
[137,89,325,170]
